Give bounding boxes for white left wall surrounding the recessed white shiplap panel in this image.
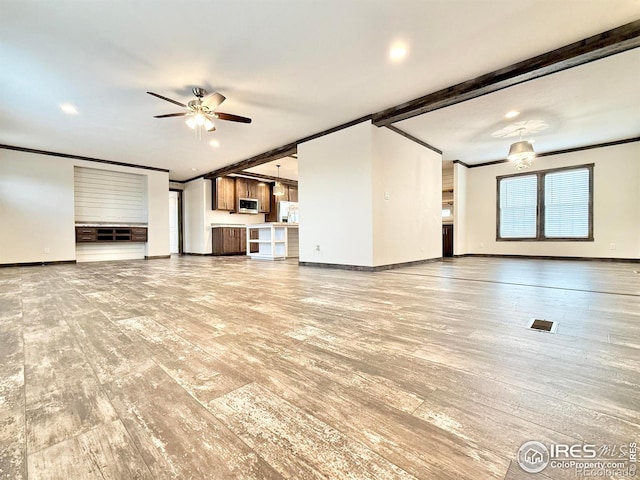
[0,149,169,264]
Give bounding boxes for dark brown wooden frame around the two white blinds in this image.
[496,163,595,242]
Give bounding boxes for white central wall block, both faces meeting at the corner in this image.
[298,122,442,267]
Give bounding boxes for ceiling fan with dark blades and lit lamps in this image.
[147,87,251,132]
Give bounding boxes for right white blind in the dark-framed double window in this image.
[544,168,589,238]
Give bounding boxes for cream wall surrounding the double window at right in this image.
[464,142,640,258]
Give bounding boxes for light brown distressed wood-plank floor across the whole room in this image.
[0,257,640,480]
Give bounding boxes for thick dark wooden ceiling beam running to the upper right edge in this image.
[372,20,640,127]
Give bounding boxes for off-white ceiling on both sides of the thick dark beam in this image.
[0,0,640,180]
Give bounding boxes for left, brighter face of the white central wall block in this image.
[298,118,375,266]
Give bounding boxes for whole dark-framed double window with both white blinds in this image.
[497,164,593,241]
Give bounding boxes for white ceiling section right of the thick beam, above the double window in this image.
[395,48,640,165]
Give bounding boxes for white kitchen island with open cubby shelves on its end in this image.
[247,222,298,260]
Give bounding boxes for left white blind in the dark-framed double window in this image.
[500,175,538,238]
